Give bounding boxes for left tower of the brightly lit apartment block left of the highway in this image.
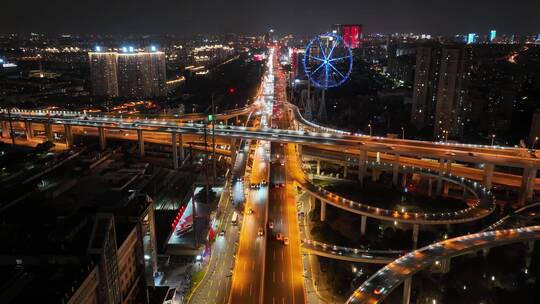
[88,49,118,97]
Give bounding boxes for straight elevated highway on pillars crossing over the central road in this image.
[0,105,540,202]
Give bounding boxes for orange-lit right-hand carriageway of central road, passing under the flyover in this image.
[263,52,306,304]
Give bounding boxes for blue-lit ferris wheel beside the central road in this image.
[304,33,353,89]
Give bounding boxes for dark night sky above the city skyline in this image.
[4,0,540,35]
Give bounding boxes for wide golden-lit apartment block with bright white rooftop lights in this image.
[89,47,166,98]
